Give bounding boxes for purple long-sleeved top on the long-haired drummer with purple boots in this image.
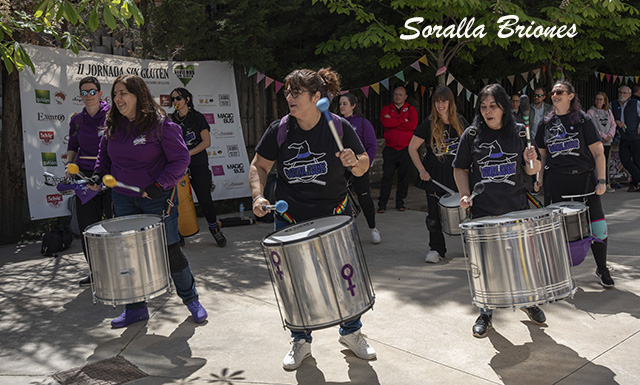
[95,117,191,196]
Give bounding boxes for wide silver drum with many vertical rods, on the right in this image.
[460,208,576,309]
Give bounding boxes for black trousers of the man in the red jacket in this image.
[378,146,411,207]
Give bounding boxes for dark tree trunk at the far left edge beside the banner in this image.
[0,66,29,245]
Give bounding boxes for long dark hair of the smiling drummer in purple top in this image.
[107,74,167,137]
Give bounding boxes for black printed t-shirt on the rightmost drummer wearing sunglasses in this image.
[536,114,600,174]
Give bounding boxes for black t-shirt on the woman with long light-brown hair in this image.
[413,115,468,193]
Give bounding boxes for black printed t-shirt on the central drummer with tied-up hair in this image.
[256,116,365,221]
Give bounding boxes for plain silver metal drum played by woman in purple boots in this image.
[83,215,171,306]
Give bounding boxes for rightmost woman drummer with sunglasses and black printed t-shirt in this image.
[536,80,614,288]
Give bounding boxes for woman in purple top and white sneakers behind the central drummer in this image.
[340,92,382,244]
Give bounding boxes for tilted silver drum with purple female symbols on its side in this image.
[262,215,375,330]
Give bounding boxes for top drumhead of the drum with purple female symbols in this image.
[262,215,353,246]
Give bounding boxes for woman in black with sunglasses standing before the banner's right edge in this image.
[171,87,227,247]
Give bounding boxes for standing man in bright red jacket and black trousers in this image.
[378,86,418,213]
